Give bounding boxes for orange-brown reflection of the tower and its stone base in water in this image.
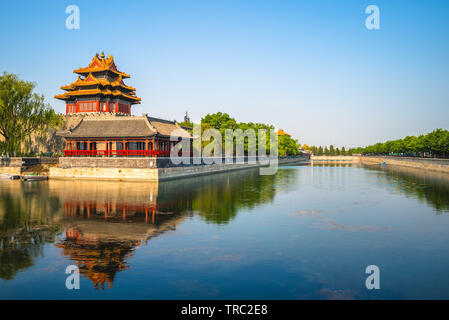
[49,181,191,289]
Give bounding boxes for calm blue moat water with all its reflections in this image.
[0,165,449,299]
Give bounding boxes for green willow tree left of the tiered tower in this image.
[0,72,62,155]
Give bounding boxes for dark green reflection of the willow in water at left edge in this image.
[0,182,60,280]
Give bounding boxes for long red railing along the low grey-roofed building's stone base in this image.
[64,150,170,157]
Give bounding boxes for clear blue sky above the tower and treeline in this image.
[0,0,449,146]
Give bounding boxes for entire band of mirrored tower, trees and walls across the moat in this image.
[0,163,449,289]
